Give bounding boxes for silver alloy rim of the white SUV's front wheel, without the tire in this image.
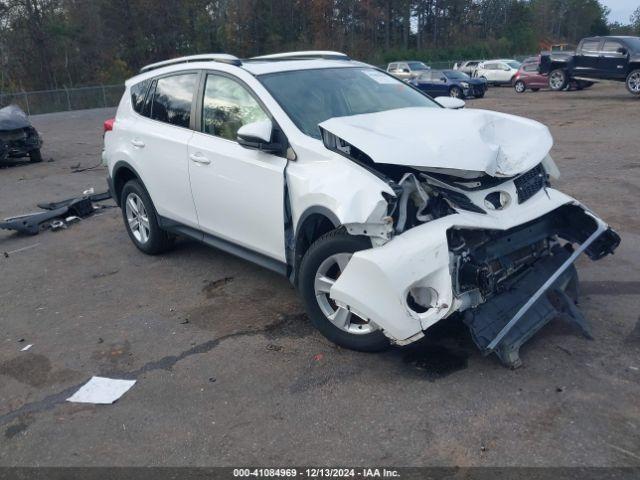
[313,253,376,335]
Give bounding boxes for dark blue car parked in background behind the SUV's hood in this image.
[409,70,487,98]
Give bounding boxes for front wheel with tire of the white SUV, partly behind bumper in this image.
[298,229,389,352]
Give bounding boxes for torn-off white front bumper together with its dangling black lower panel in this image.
[330,189,620,366]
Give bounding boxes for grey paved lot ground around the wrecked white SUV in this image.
[0,85,640,466]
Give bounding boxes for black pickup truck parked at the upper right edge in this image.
[540,36,640,96]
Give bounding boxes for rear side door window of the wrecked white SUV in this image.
[150,72,198,128]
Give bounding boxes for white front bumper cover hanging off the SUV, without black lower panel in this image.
[330,189,620,364]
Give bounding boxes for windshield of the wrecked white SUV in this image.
[258,68,439,139]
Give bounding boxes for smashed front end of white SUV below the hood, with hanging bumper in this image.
[323,112,620,368]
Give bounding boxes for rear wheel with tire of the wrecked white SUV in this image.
[120,180,173,255]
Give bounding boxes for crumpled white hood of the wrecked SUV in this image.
[319,107,553,177]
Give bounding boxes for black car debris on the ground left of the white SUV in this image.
[0,192,111,235]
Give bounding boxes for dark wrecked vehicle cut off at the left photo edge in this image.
[0,105,42,163]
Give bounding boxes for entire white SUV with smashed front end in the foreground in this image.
[103,52,620,367]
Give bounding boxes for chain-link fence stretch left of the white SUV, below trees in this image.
[0,84,124,115]
